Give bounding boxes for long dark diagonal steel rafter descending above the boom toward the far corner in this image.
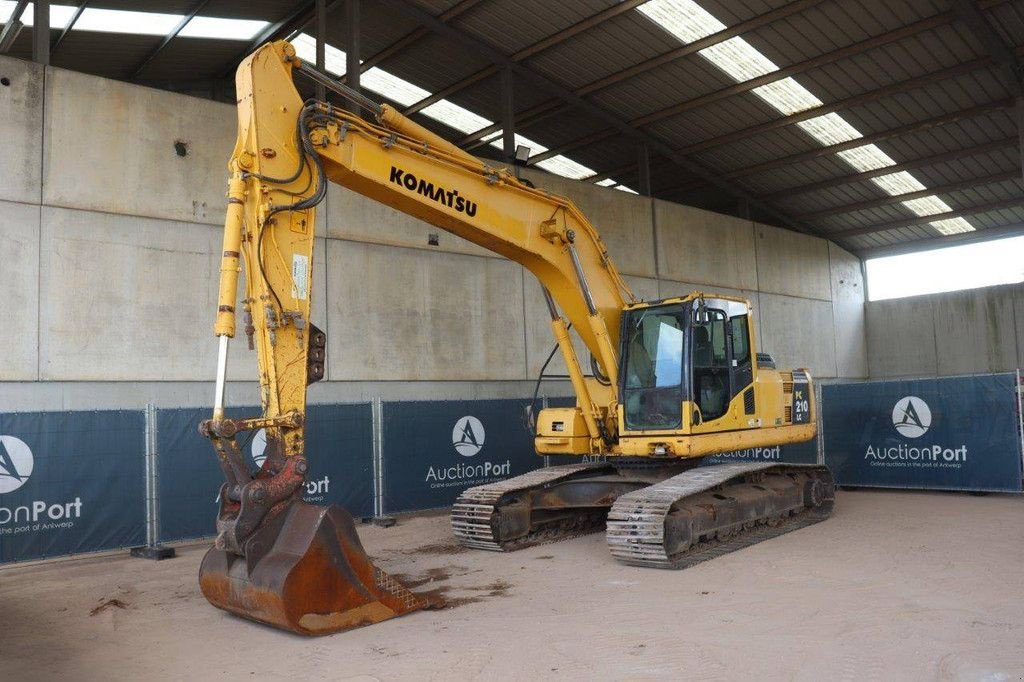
[383,0,816,233]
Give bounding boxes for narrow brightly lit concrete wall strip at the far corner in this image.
[828,243,867,378]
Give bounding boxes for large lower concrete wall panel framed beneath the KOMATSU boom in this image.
[328,240,526,381]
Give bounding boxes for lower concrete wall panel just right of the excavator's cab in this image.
[759,292,837,379]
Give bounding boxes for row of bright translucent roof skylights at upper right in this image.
[637,0,974,235]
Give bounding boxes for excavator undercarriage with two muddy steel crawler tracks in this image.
[452,460,836,568]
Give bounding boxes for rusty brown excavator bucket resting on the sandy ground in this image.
[199,501,428,635]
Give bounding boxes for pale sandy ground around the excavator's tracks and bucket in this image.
[0,491,1024,680]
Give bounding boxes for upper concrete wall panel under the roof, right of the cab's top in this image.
[754,224,831,301]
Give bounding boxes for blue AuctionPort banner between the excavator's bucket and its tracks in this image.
[383,399,544,513]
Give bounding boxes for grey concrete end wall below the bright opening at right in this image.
[866,284,1024,378]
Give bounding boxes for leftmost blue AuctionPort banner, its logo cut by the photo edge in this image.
[0,411,145,562]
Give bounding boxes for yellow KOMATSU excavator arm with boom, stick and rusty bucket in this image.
[200,41,634,634]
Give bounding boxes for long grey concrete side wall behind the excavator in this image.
[0,57,866,410]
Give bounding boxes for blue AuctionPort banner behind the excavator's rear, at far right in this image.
[822,374,1021,493]
